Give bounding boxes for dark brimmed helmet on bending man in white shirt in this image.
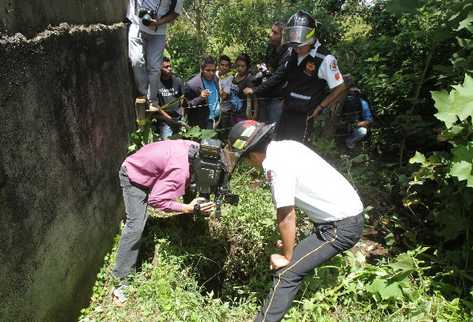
[224,120,276,172]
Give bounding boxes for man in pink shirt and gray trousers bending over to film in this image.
[113,140,214,303]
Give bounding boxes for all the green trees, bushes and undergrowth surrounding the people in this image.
[82,0,473,321]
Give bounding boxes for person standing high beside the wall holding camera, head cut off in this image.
[127,0,183,102]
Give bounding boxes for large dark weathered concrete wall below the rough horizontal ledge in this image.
[0,24,132,321]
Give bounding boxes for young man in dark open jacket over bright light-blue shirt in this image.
[184,56,220,129]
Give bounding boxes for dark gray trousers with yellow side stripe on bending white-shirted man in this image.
[255,214,363,322]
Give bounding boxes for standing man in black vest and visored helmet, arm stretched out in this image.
[244,11,345,142]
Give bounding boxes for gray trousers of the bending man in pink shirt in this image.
[113,167,148,279]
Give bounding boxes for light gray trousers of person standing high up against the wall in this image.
[128,24,166,102]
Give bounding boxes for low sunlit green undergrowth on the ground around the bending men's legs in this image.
[82,167,467,321]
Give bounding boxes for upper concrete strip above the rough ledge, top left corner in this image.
[0,0,128,37]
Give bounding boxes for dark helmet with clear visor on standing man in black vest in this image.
[282,10,317,47]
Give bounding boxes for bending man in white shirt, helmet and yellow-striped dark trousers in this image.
[227,121,363,322]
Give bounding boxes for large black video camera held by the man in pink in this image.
[189,139,240,219]
